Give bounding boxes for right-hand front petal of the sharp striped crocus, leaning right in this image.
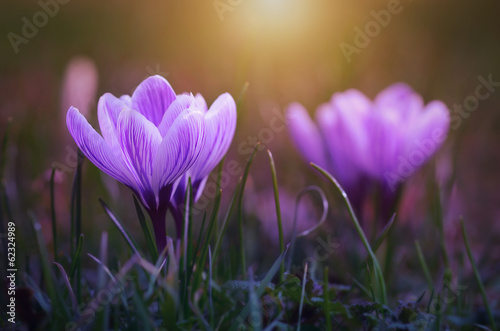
[153,109,205,195]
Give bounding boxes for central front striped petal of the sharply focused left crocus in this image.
[117,109,161,207]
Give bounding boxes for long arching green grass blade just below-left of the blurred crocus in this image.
[311,163,387,304]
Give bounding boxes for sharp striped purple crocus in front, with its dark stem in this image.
[66,76,206,251]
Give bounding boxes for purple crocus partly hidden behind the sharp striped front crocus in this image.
[170,93,236,235]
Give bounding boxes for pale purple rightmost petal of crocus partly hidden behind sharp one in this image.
[189,93,236,181]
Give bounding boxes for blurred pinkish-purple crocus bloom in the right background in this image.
[287,83,450,218]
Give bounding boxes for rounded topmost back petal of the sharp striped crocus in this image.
[132,75,176,126]
